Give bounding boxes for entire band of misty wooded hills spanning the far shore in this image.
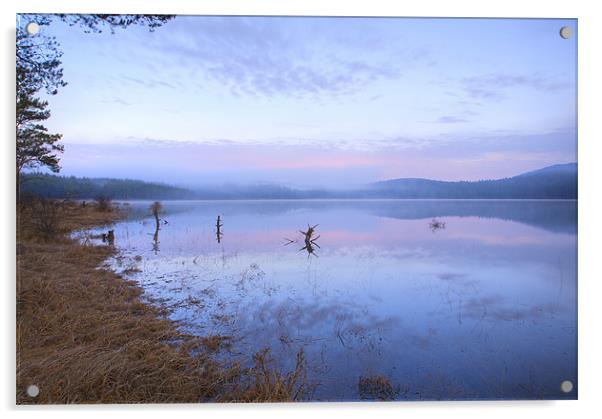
[21,163,577,200]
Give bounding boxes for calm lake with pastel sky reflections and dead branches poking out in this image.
[85,200,577,401]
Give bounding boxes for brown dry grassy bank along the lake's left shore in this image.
[16,200,305,404]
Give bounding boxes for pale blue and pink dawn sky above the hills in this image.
[25,16,577,187]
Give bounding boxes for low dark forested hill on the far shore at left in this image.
[20,173,194,200]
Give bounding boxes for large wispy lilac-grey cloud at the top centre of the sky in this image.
[135,17,430,97]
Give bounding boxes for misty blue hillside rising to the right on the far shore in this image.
[365,163,577,199]
